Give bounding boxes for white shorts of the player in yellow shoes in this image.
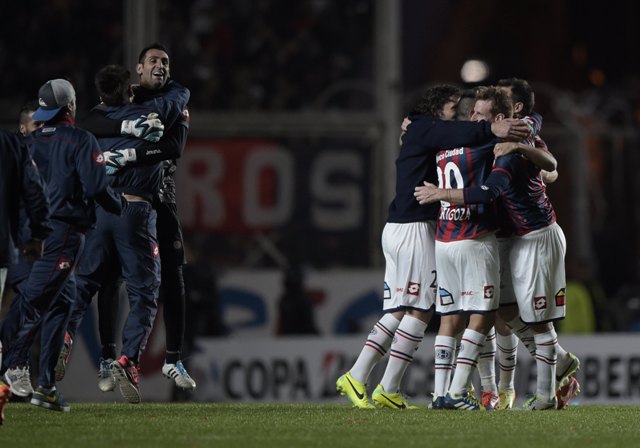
[382,222,436,312]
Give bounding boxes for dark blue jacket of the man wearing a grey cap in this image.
[28,123,122,229]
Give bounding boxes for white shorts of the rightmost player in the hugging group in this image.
[509,223,567,324]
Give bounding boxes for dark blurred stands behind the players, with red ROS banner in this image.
[0,0,640,331]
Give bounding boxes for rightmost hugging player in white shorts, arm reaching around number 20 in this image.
[418,84,577,410]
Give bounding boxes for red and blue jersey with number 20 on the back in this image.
[436,141,498,242]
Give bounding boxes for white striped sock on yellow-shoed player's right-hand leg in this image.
[380,314,427,394]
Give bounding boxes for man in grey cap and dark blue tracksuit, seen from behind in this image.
[0,79,126,411]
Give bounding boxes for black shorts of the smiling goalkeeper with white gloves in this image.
[153,200,187,266]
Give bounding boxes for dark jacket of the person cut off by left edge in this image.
[0,130,51,267]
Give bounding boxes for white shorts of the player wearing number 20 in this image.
[436,234,500,314]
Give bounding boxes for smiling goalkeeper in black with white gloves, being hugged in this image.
[60,43,196,390]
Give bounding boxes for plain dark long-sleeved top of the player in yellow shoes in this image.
[387,115,494,223]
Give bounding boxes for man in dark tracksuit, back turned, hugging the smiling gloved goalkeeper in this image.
[65,65,189,403]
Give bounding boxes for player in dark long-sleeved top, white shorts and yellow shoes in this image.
[336,85,528,409]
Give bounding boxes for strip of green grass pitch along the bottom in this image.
[0,403,640,448]
